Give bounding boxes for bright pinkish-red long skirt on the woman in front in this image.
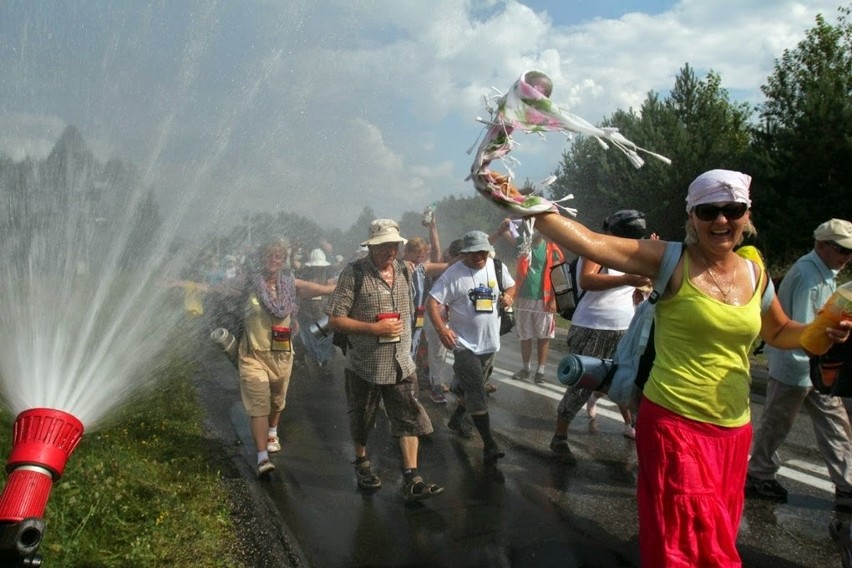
[636,398,752,568]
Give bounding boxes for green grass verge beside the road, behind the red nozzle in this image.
[0,358,242,567]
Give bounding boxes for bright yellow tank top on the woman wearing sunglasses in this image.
[644,255,763,427]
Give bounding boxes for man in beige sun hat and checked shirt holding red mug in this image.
[326,219,444,501]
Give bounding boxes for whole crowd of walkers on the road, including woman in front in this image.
[170,170,852,566]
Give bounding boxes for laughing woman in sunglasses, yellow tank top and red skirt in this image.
[535,170,849,567]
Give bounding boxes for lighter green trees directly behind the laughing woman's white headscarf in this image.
[551,64,752,239]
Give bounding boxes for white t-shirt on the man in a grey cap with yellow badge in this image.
[429,258,515,355]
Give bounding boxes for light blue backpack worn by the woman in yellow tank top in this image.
[607,242,775,408]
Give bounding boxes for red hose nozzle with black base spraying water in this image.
[0,408,83,566]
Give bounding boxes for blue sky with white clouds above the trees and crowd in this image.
[0,0,842,235]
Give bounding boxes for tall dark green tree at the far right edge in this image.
[752,6,852,263]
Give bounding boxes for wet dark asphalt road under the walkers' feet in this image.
[198,335,849,568]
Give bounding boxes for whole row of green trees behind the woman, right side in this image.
[548,6,852,267]
